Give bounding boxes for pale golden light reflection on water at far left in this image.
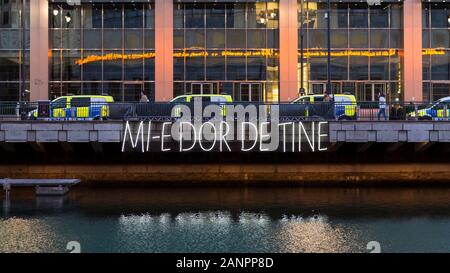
[0,218,61,253]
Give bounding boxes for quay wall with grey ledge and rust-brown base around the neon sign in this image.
[0,121,450,185]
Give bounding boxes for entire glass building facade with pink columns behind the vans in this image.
[0,0,450,102]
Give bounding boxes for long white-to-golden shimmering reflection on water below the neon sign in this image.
[119,211,364,253]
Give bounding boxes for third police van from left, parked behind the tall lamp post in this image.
[293,94,357,120]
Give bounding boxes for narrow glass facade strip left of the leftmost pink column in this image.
[0,0,30,101]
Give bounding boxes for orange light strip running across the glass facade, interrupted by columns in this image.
[75,48,445,65]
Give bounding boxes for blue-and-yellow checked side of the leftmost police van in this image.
[29,95,114,120]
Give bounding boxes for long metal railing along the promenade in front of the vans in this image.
[0,101,450,121]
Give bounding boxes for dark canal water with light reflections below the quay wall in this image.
[0,187,450,253]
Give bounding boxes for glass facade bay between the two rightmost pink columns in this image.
[298,0,403,101]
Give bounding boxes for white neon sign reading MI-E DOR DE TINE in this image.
[122,99,329,153]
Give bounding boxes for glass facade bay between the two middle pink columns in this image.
[174,0,279,101]
